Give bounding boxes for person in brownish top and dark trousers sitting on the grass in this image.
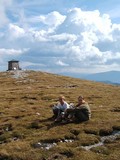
[64,96,91,122]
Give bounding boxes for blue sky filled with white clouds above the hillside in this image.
[0,0,120,75]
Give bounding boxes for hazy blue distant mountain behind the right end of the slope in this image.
[82,71,120,85]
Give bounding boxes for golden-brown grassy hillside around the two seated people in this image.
[0,71,120,160]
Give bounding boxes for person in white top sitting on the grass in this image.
[53,96,69,122]
